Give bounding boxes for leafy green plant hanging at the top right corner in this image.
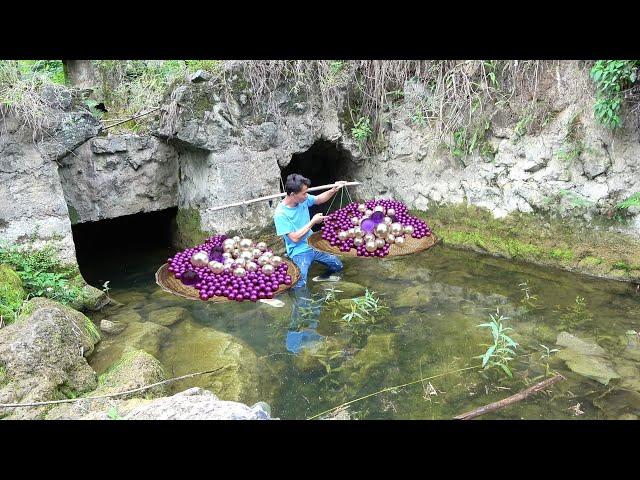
[591,60,640,129]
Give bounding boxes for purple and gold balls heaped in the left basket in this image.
[167,235,292,302]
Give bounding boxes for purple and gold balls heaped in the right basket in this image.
[322,200,431,257]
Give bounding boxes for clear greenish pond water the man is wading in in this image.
[82,245,640,419]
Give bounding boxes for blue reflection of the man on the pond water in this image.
[286,285,325,354]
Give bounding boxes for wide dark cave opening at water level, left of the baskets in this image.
[71,207,178,288]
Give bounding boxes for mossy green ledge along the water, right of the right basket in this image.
[410,203,640,281]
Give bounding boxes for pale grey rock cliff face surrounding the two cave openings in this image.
[0,61,640,274]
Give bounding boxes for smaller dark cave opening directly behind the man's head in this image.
[280,140,353,223]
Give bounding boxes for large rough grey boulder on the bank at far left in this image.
[0,298,100,419]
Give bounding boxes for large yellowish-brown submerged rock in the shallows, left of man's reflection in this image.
[160,321,269,404]
